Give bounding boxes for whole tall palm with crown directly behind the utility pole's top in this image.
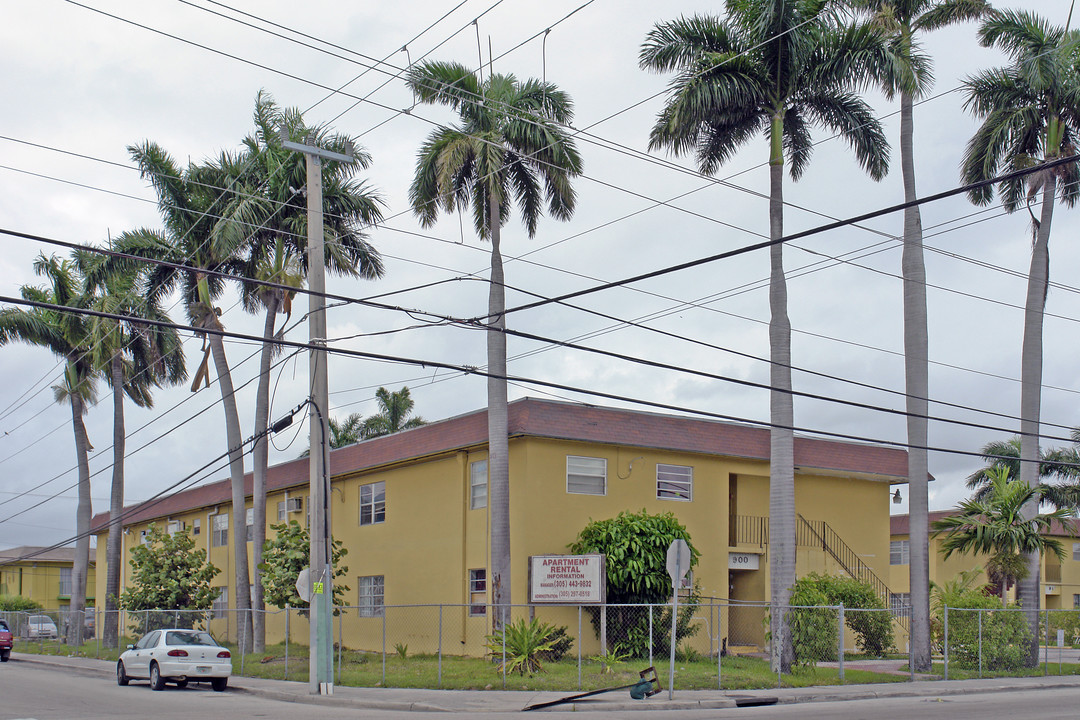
[224,92,383,652]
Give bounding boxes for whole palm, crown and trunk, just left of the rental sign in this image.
[408,62,581,627]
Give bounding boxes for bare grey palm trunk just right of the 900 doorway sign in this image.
[769,111,795,673]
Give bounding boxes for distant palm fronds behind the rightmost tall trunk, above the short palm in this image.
[967,429,1080,510]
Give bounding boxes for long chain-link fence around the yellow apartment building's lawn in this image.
[10,598,1080,689]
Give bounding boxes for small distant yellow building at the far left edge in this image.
[0,545,96,610]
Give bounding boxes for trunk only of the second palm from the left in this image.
[102,351,126,648]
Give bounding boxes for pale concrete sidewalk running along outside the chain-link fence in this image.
[11,653,1080,712]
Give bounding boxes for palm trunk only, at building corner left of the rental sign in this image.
[487,187,513,630]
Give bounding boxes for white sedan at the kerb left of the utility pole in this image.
[117,629,232,692]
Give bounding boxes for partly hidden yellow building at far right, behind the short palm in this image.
[888,511,1080,610]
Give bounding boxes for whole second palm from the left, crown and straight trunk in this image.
[75,252,187,648]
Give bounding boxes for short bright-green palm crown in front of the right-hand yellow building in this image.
[933,466,1071,607]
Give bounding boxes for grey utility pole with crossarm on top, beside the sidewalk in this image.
[281,128,355,695]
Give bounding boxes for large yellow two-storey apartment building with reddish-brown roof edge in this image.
[93,398,907,652]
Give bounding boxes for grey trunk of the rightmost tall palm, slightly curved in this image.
[1016,173,1057,667]
